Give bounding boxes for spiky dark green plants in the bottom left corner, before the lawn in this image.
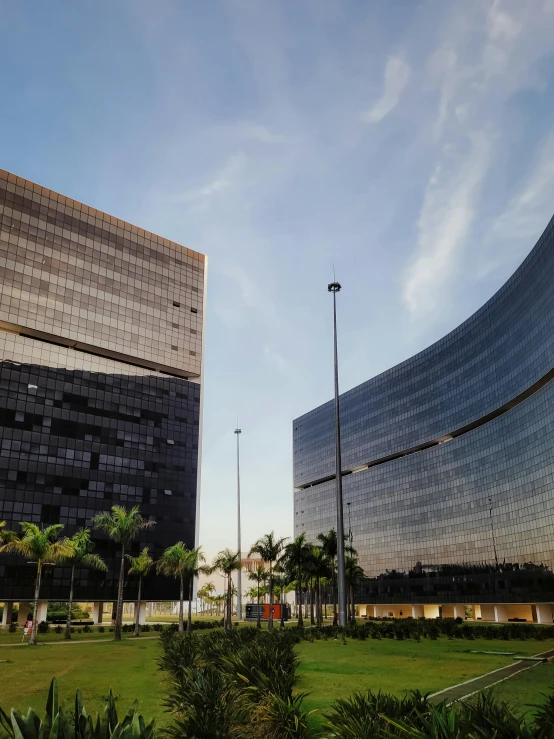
[0,678,155,739]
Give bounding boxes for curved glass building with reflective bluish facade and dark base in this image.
[293,219,554,620]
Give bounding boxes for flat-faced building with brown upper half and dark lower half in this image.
[0,170,206,602]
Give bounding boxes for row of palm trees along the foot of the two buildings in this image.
[0,505,364,644]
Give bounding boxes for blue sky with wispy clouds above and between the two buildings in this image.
[0,0,554,568]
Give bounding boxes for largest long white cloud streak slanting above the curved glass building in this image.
[403,134,492,319]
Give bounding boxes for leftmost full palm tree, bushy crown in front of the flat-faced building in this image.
[0,521,73,644]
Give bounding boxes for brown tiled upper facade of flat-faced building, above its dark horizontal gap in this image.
[0,170,205,377]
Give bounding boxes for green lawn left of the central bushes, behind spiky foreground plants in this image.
[0,639,166,723]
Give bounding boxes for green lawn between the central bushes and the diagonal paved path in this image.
[297,638,554,724]
